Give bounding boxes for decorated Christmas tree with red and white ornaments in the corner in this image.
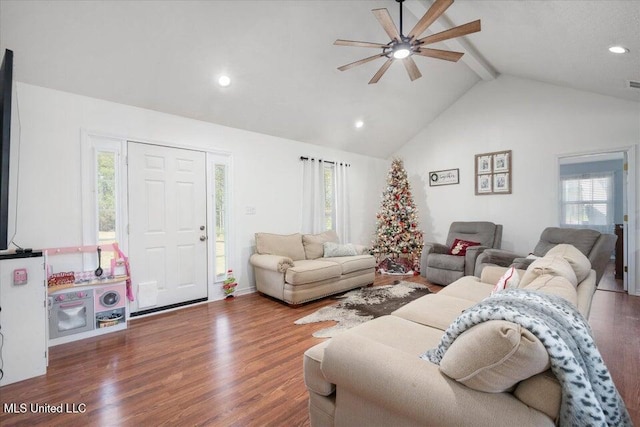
[371,159,423,272]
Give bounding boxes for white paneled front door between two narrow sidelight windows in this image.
[128,141,207,312]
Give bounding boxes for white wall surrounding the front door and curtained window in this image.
[12,82,389,298]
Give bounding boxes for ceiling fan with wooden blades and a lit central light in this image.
[334,0,480,84]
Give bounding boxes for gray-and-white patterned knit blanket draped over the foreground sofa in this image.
[420,289,633,427]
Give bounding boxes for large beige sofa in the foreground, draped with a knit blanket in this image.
[304,245,596,427]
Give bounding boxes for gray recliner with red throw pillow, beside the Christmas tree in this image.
[420,221,502,286]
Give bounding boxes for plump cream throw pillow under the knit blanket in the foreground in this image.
[440,320,550,393]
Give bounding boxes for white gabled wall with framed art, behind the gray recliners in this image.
[396,75,640,292]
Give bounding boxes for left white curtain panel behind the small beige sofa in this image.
[302,159,325,234]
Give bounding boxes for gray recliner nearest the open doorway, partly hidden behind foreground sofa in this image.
[474,227,618,284]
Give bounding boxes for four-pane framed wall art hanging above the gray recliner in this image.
[475,150,513,196]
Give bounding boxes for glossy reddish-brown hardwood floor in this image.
[0,276,640,426]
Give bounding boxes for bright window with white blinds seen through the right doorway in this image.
[561,172,614,233]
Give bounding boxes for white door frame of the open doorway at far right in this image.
[556,145,640,296]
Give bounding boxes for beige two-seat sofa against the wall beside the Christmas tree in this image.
[250,231,376,305]
